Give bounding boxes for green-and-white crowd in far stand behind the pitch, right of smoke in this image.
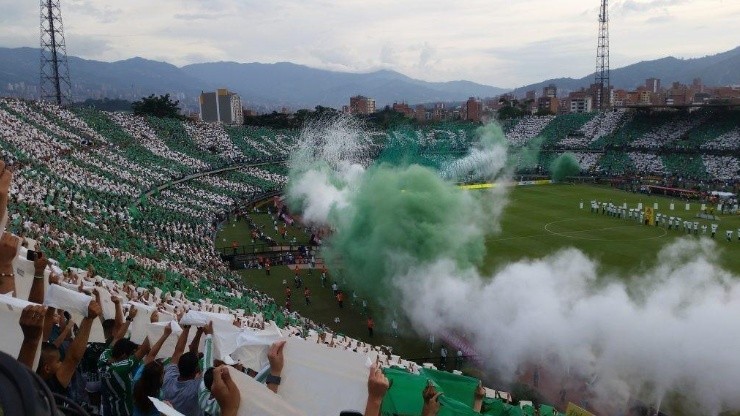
[498,109,740,181]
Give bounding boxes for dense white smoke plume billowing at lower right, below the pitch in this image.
[394,239,740,414]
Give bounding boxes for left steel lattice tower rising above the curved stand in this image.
[39,0,72,105]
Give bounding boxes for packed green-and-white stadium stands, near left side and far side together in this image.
[0,99,740,415]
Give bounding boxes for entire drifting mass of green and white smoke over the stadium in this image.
[288,119,740,414]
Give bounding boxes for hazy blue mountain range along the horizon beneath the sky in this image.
[0,47,740,110]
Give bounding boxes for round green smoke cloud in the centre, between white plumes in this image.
[324,164,485,301]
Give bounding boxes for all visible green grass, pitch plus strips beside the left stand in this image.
[217,184,740,366]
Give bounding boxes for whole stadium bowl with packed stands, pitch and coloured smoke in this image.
[0,94,740,415]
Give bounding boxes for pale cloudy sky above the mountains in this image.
[0,0,740,88]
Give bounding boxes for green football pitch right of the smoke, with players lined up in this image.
[483,184,740,276]
